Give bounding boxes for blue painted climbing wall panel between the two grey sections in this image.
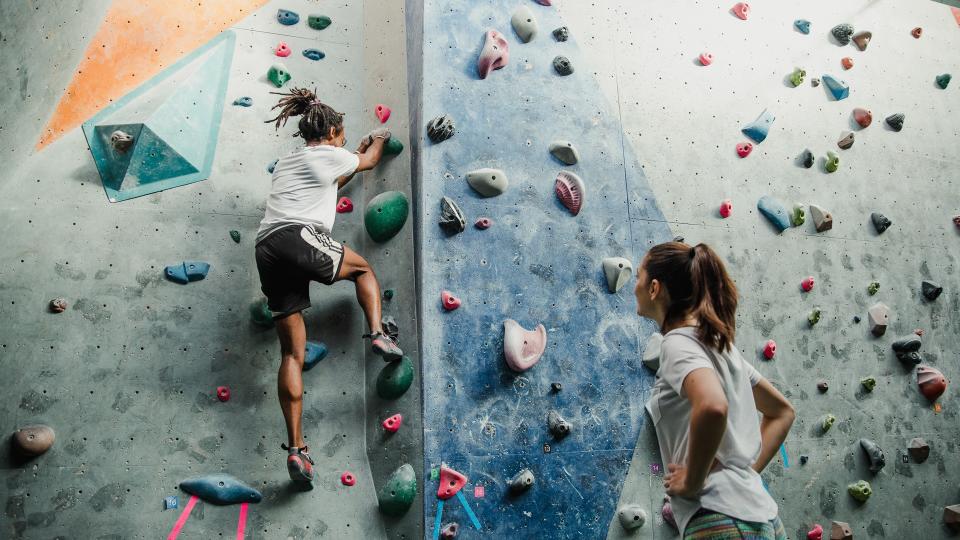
[417,0,670,538]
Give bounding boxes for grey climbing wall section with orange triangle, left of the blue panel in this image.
[0,0,422,538]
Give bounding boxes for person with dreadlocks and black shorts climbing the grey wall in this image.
[256,88,403,483]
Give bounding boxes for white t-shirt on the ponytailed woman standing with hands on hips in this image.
[647,326,777,535]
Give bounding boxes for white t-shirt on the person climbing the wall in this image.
[257,144,360,242]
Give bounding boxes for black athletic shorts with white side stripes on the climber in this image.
[256,224,343,319]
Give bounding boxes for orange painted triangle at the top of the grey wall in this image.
[36,0,267,150]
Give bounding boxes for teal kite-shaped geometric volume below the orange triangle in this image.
[83,31,236,202]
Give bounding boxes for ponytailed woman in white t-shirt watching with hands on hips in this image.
[634,242,795,540]
